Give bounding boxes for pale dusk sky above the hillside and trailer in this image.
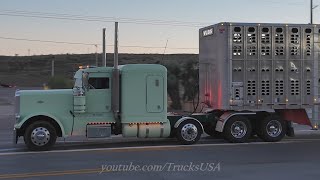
[0,0,320,55]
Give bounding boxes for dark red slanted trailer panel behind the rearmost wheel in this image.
[275,109,312,127]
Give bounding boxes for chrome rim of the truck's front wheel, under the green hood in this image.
[31,127,50,146]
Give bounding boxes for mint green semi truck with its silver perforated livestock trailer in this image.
[14,23,320,150]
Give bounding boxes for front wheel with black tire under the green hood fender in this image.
[24,121,57,151]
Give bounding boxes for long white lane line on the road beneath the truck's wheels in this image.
[0,141,302,156]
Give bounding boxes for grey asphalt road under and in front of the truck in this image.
[0,89,320,180]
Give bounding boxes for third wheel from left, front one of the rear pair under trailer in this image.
[223,116,252,143]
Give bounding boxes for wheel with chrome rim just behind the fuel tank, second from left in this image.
[176,119,203,145]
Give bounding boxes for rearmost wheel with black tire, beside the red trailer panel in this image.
[258,115,287,142]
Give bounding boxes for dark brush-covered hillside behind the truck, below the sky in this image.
[0,54,198,87]
